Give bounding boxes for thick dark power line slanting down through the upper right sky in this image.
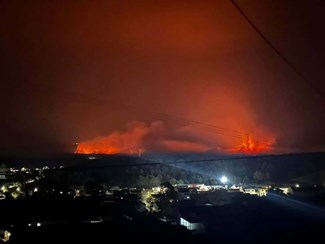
[230,0,325,99]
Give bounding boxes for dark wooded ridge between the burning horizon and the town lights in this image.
[41,153,325,187]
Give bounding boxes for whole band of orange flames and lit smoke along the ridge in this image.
[75,121,275,155]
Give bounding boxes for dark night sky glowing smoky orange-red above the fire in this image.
[0,0,325,153]
